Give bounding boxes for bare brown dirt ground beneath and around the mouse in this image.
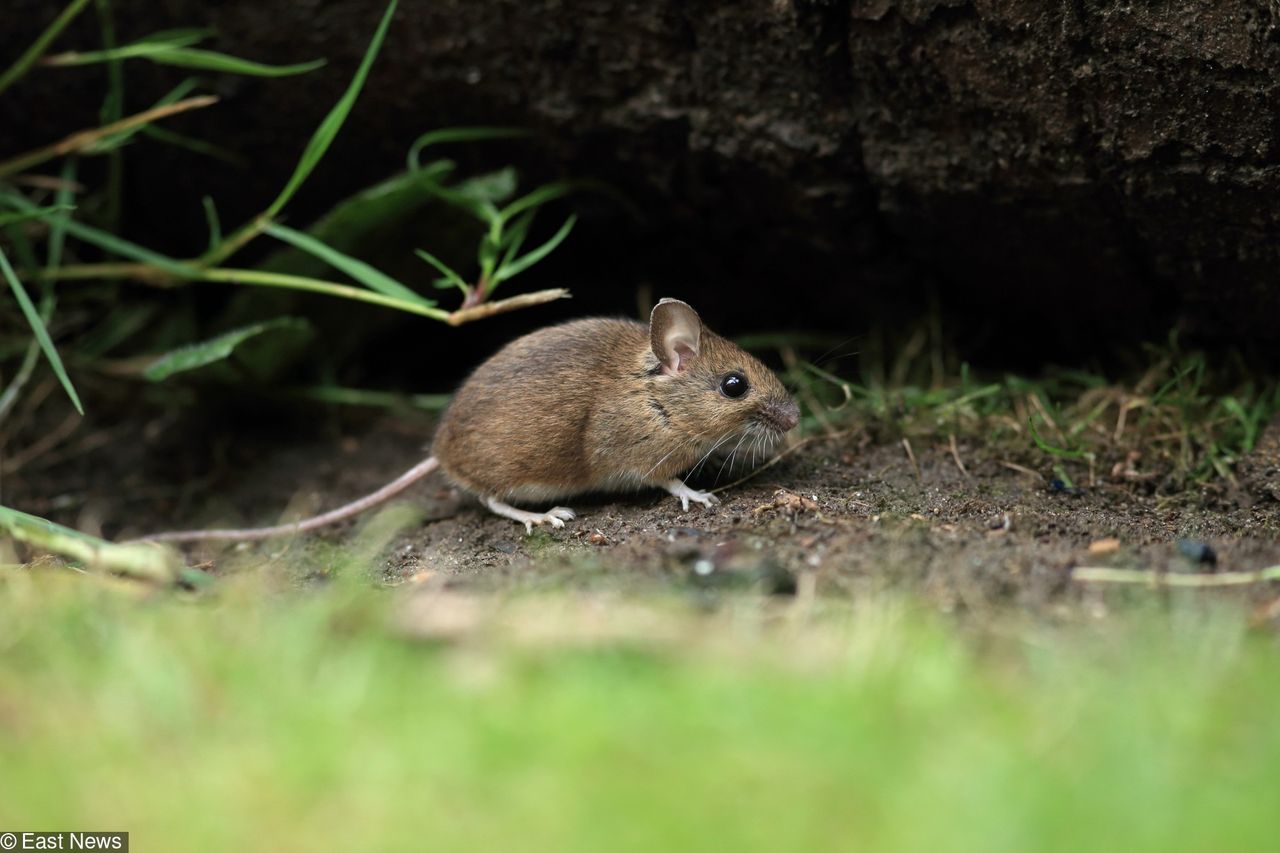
[12,404,1280,612]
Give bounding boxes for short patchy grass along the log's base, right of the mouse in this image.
[768,325,1280,493]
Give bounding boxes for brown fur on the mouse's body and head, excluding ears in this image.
[431,311,796,501]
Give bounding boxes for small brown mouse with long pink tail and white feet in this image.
[143,298,800,542]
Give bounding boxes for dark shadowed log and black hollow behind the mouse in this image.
[0,0,1280,389]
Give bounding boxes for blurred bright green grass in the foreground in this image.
[0,569,1280,852]
